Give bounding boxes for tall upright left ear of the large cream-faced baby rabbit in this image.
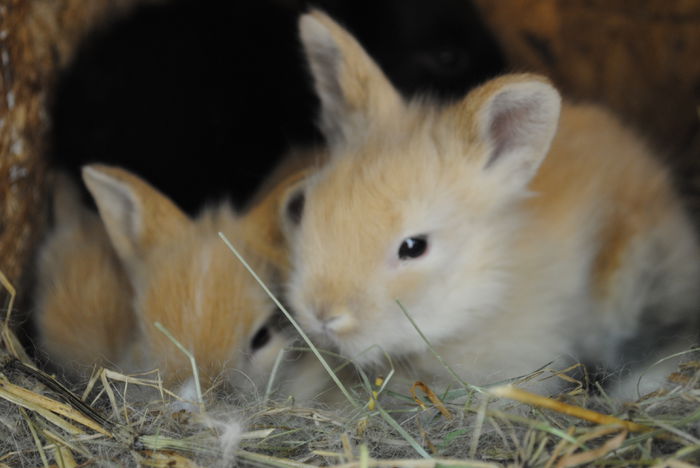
[299,10,403,145]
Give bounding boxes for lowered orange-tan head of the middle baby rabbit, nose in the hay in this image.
[83,166,296,392]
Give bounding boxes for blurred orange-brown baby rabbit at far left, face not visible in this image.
[35,174,136,377]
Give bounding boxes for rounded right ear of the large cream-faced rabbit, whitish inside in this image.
[467,75,561,189]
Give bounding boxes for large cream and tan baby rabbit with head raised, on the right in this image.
[287,11,700,394]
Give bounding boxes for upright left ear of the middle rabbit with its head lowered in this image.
[83,164,189,268]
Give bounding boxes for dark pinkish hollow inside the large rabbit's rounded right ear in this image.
[485,92,540,168]
